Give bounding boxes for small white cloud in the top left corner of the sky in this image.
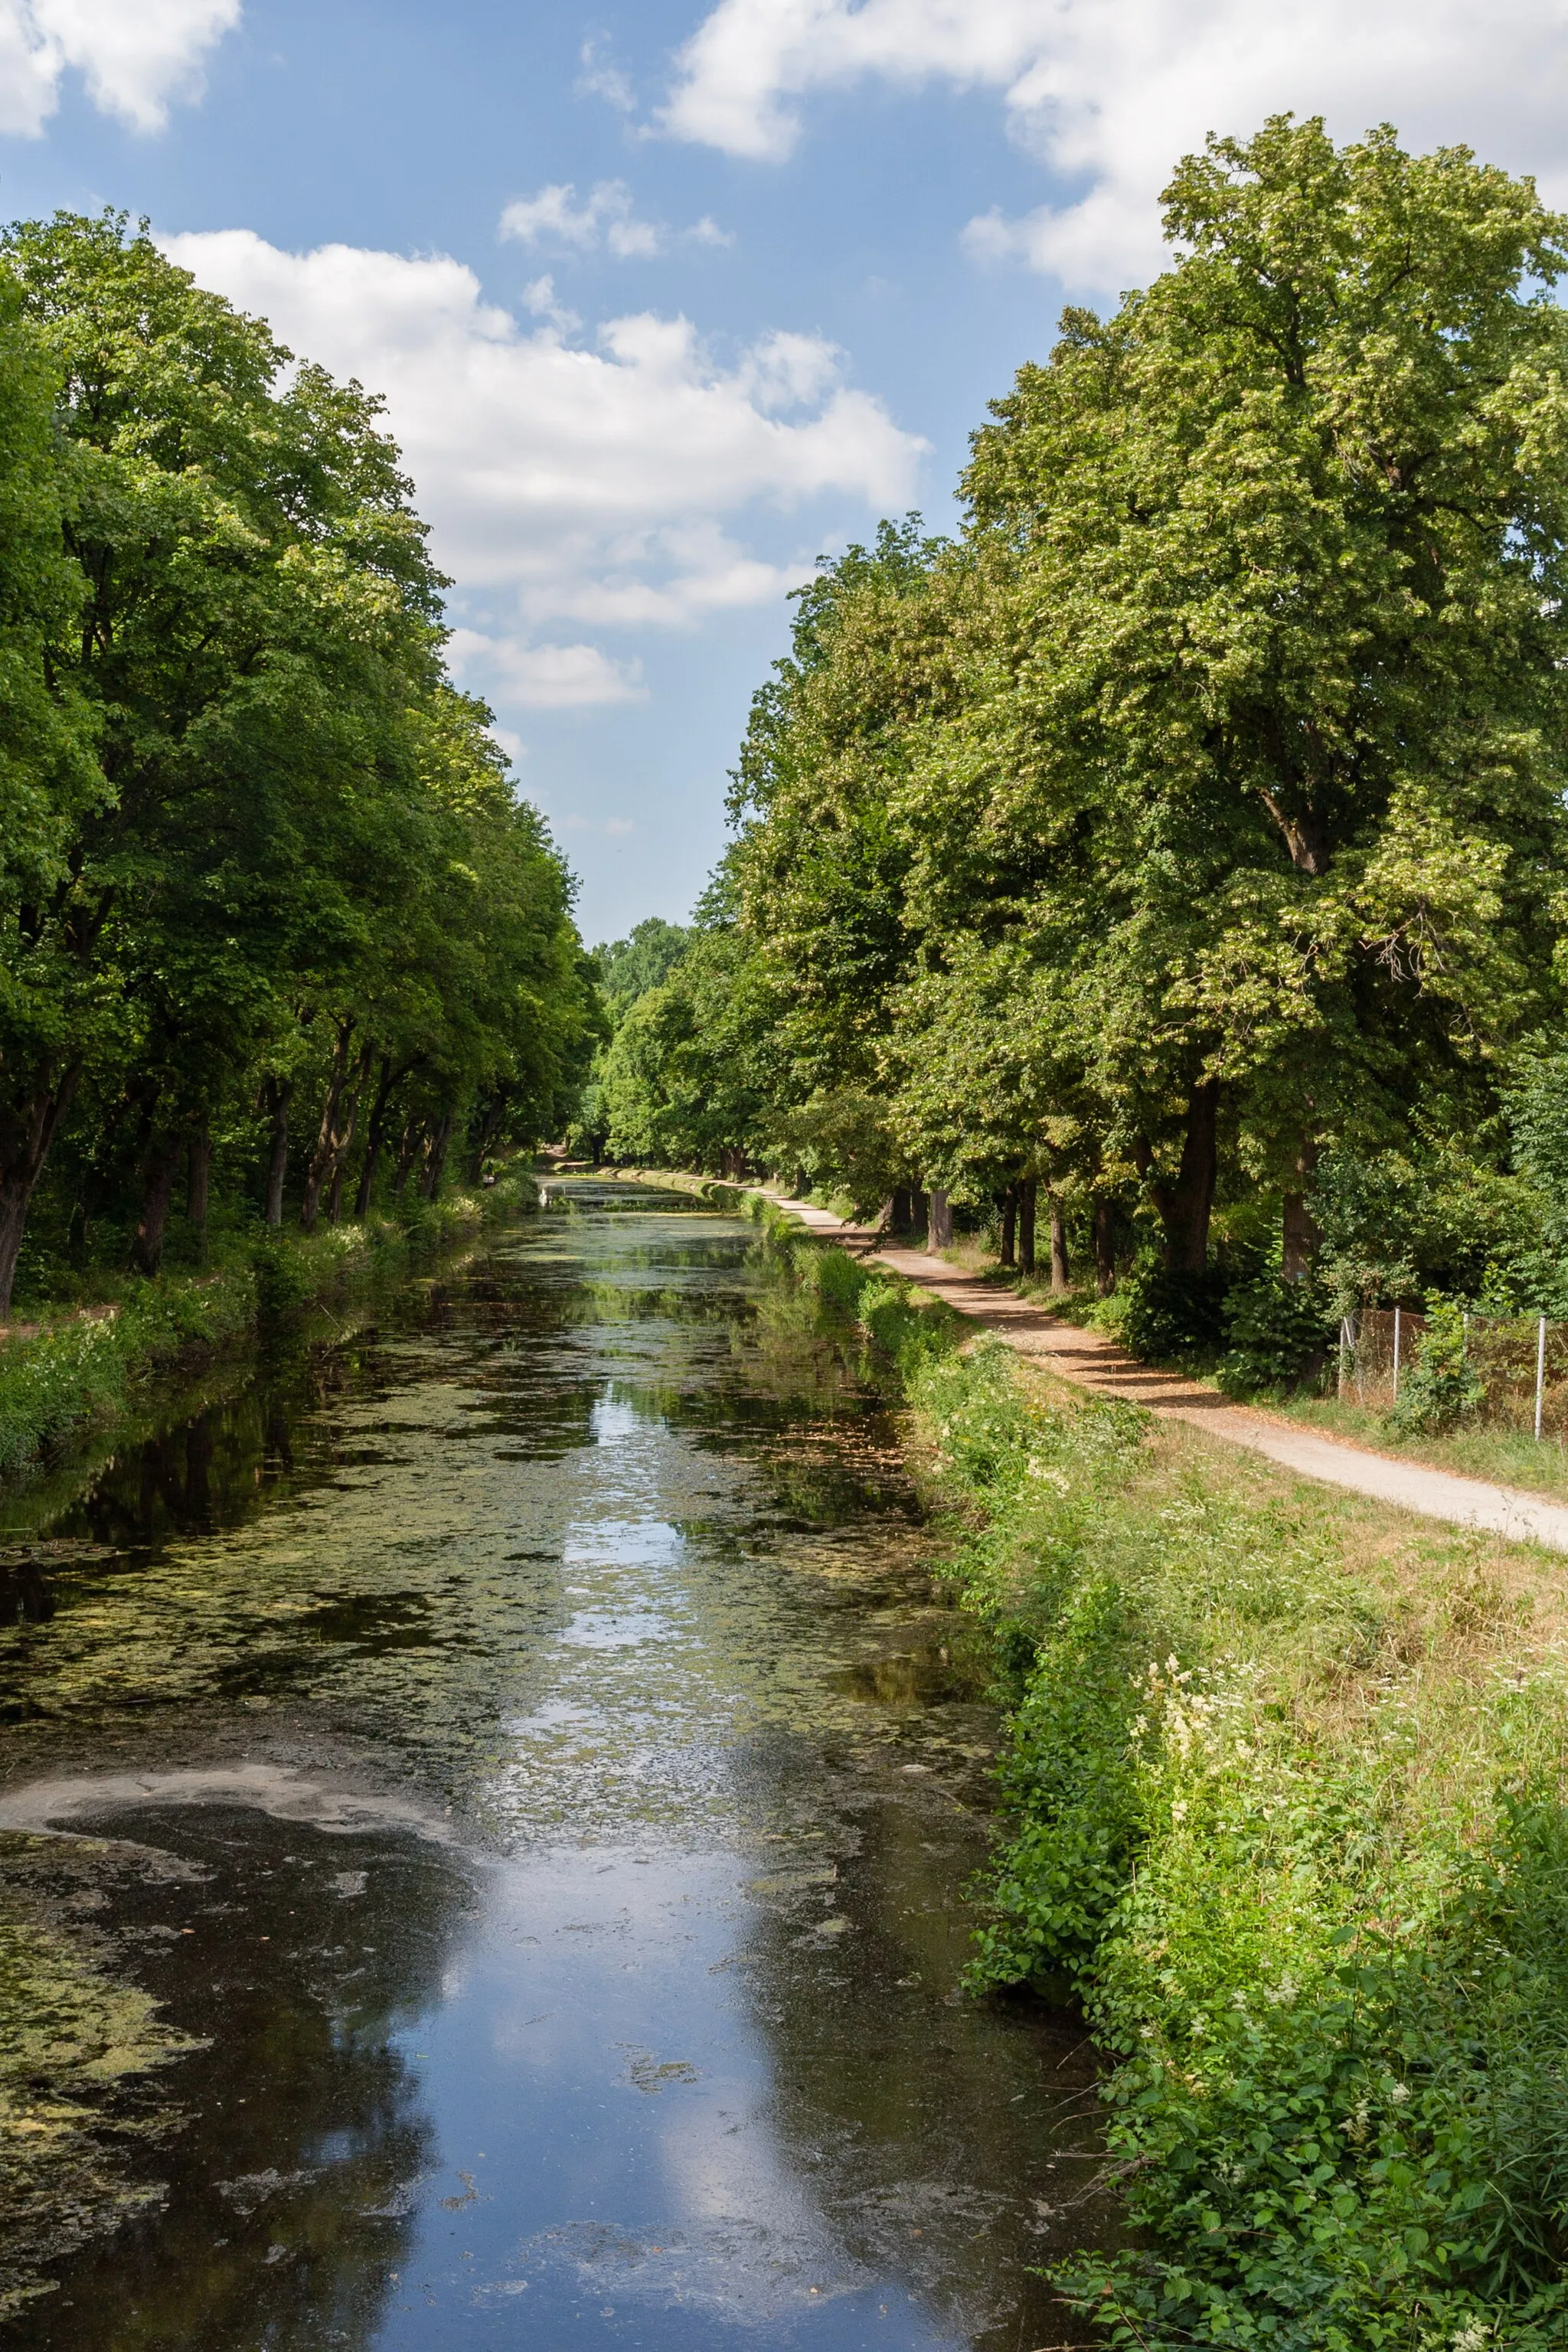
[0,0,240,139]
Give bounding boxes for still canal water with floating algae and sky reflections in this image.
[0,1181,1107,2352]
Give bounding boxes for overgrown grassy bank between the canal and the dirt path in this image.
[764,1211,1568,2352]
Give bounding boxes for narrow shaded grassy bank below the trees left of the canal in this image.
[0,1169,534,1479]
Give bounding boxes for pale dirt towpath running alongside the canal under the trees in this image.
[752,1195,1568,1553]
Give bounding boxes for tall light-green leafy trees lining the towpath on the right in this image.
[583,118,1568,1345]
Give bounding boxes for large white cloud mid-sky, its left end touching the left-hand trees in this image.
[165,228,926,708]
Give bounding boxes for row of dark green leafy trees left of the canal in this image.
[0,214,602,1317]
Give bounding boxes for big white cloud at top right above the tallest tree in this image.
[661,0,1568,292]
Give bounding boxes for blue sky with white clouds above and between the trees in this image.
[0,0,1568,939]
